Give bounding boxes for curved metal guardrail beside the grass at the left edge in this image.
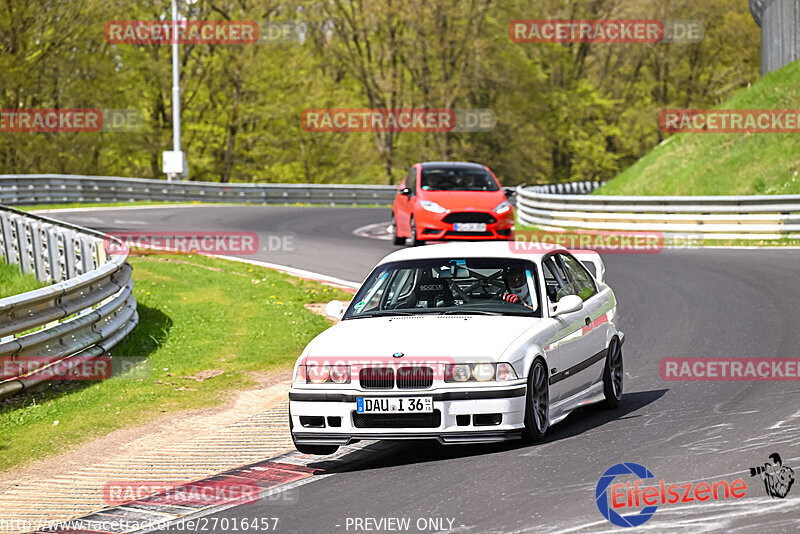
[0,206,139,398]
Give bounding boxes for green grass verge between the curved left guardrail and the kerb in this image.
[0,255,350,470]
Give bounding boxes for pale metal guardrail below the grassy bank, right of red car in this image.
[517,186,800,239]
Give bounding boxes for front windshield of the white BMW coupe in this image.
[343,258,541,319]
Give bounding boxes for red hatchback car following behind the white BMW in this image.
[392,162,514,246]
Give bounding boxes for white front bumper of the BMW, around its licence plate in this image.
[289,381,526,445]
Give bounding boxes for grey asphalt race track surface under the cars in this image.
[51,206,800,533]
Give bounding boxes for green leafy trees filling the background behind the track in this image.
[0,0,759,185]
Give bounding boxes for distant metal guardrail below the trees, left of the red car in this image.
[0,174,397,205]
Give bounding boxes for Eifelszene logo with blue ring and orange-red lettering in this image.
[595,462,752,528]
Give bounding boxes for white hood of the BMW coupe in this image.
[306,315,541,363]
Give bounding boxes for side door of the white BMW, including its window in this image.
[542,253,595,401]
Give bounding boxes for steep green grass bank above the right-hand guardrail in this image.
[594,61,800,195]
